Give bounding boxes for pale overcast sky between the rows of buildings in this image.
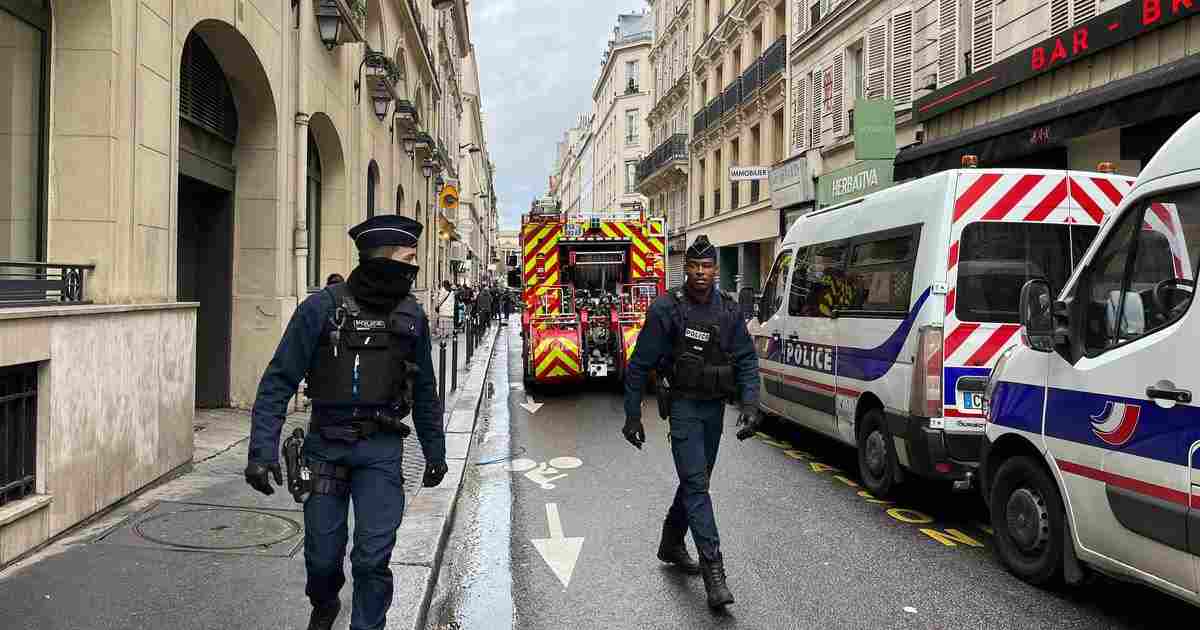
[470,0,646,229]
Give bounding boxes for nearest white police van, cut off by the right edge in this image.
[980,111,1200,604]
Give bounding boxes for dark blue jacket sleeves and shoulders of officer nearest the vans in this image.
[625,288,758,418]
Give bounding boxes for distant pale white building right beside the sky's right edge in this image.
[583,12,654,210]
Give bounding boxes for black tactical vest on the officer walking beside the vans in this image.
[671,288,737,401]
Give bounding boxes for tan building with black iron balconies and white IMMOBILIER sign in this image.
[688,0,788,290]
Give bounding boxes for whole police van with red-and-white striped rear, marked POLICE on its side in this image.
[750,162,1133,496]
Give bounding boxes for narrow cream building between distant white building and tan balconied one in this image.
[637,0,692,287]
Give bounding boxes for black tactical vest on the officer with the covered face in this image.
[307,282,421,420]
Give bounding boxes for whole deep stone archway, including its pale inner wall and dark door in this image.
[174,19,279,407]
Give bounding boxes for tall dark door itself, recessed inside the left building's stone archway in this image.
[175,32,238,407]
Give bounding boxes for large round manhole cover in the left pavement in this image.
[133,508,300,551]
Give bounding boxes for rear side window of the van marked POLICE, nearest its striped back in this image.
[839,229,919,316]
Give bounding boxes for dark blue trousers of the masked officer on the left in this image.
[304,432,404,630]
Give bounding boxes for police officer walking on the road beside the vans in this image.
[622,235,758,608]
